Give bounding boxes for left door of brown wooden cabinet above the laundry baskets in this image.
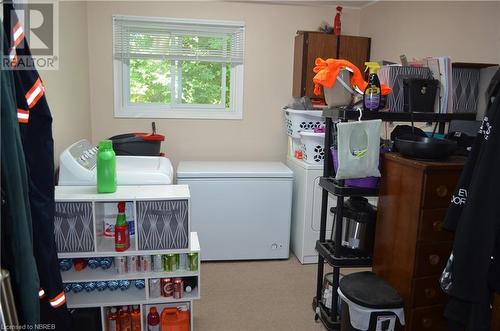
[303,33,337,98]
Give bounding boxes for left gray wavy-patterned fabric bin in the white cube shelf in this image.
[54,202,94,253]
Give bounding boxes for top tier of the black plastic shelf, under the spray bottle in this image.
[323,108,476,122]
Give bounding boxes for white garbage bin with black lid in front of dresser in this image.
[338,271,405,331]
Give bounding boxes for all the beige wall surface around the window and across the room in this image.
[45,1,500,165]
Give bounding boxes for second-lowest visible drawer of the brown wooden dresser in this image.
[411,276,448,307]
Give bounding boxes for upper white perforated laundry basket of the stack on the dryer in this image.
[283,108,325,138]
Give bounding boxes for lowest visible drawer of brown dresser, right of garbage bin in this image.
[406,305,448,331]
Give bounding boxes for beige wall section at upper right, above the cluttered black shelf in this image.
[360,1,500,63]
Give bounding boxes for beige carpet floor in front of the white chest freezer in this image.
[194,254,370,331]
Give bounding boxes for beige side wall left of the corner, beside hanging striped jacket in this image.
[39,2,91,163]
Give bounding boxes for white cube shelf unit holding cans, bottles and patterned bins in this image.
[55,185,200,330]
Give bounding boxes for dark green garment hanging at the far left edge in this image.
[0,26,40,326]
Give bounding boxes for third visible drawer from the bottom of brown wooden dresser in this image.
[414,243,453,277]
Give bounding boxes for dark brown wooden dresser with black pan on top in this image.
[373,153,465,331]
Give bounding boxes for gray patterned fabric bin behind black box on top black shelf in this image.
[377,66,433,112]
